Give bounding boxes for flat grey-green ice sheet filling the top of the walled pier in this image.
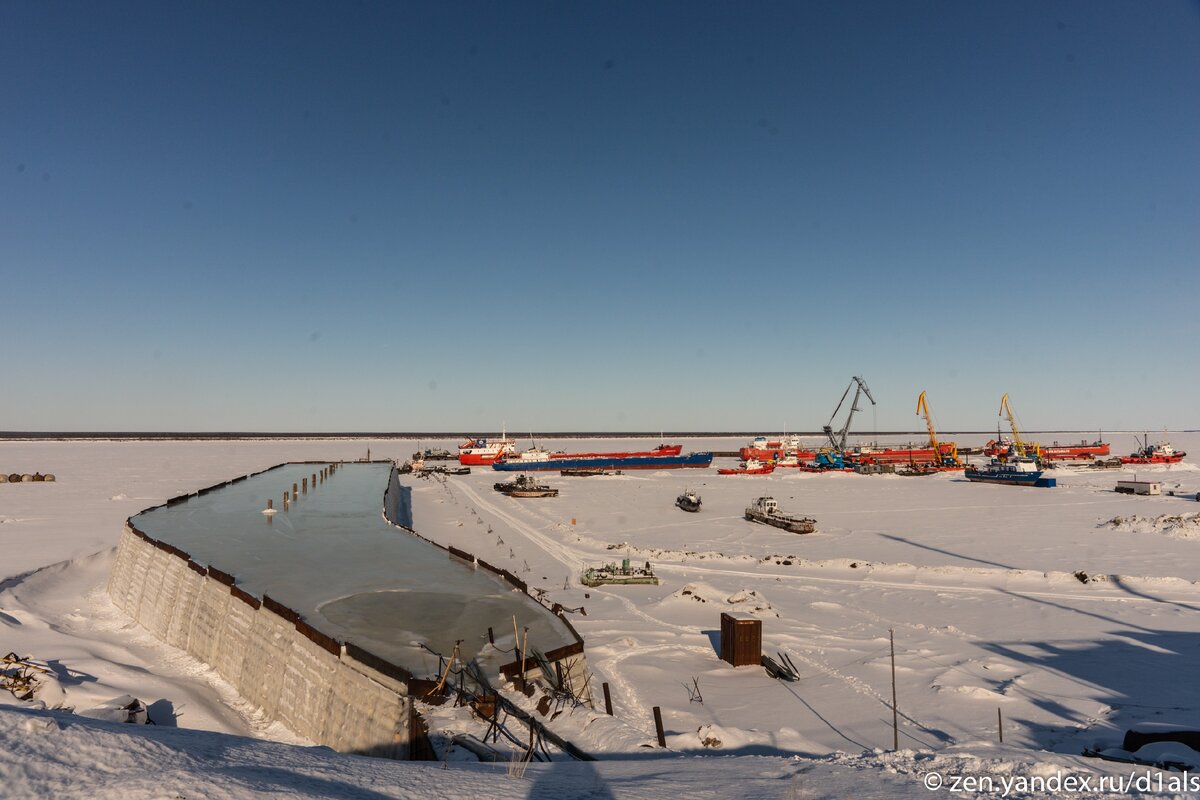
[131,463,575,675]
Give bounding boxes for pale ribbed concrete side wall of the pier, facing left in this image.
[108,524,412,758]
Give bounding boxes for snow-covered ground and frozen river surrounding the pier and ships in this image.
[0,434,1200,798]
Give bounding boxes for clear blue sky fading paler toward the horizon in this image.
[0,0,1200,431]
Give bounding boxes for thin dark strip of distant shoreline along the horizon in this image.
[0,428,1195,441]
